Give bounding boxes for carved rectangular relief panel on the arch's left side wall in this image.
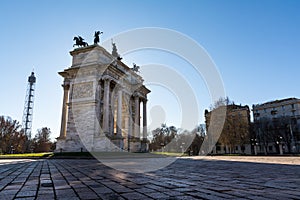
[72,81,93,99]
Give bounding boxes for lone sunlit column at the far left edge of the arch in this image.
[59,83,70,139]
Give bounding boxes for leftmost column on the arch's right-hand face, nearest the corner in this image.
[103,79,110,134]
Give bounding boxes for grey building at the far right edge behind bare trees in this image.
[252,98,300,154]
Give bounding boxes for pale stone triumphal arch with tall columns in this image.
[55,41,150,152]
